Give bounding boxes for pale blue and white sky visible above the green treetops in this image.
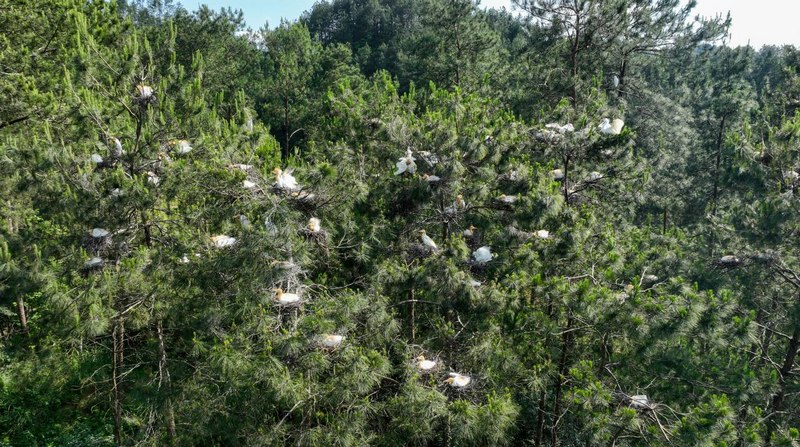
[179,0,800,48]
